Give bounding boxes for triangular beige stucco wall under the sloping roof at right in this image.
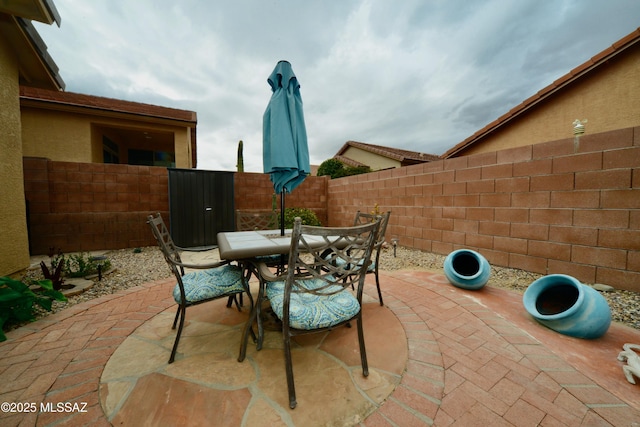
[462,45,640,155]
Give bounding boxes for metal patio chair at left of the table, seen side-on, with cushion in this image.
[147,213,253,363]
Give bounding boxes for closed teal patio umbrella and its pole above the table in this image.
[262,61,311,235]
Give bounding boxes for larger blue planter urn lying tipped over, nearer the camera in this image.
[522,274,611,339]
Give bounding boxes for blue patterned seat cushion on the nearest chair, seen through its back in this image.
[266,279,360,330]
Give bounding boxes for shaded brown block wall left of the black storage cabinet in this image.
[23,157,169,254]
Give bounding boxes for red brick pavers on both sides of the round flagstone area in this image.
[0,271,640,427]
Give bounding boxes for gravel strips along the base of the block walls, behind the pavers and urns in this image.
[14,246,640,329]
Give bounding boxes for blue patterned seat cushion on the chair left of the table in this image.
[173,265,245,304]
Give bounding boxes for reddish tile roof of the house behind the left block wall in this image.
[20,86,198,125]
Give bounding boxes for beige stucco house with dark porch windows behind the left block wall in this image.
[20,86,197,168]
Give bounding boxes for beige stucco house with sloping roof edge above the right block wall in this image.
[442,28,640,158]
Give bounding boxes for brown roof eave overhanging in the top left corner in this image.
[0,0,64,90]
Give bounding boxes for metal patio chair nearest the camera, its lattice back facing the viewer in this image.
[238,218,380,409]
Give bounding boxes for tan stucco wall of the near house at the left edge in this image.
[0,37,29,275]
